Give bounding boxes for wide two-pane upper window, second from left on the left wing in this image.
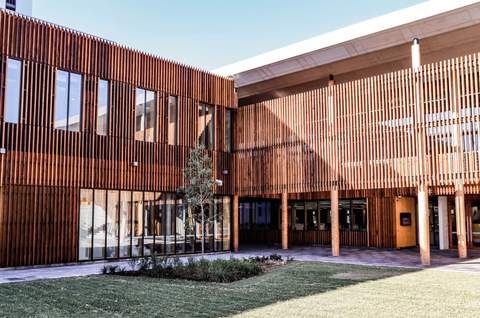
[53,70,82,131]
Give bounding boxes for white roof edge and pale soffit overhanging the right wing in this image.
[213,0,480,87]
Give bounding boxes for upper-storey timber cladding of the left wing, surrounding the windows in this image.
[0,11,235,194]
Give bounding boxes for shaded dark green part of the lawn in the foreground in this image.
[0,262,420,317]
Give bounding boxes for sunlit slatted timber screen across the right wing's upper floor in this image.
[235,54,480,195]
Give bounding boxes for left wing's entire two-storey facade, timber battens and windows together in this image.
[0,11,235,267]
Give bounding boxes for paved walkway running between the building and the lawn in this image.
[0,246,480,284]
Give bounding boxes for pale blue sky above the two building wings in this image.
[33,0,423,70]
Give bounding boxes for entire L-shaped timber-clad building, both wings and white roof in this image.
[0,0,480,267]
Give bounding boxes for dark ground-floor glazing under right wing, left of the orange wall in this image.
[239,198,368,246]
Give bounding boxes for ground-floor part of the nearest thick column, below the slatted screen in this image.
[418,185,430,266]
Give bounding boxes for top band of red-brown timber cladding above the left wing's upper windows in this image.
[0,10,235,106]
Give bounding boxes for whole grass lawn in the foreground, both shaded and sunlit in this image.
[0,262,480,317]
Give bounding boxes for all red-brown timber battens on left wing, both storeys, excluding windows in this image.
[0,10,235,267]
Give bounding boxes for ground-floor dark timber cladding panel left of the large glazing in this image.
[0,186,79,267]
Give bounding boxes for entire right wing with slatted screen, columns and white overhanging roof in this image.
[216,0,480,265]
